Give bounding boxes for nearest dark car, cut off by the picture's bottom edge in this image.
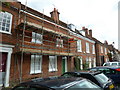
[12,77,102,90]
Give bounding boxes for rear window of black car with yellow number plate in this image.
[95,73,109,84]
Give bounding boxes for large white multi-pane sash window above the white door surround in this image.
[0,12,12,34]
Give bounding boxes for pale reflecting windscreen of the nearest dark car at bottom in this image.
[65,80,100,90]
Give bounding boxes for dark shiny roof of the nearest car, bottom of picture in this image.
[18,77,86,88]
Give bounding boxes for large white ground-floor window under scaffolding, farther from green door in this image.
[30,55,42,74]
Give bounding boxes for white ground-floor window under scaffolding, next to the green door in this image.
[49,56,58,72]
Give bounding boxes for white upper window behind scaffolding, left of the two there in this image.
[32,32,43,44]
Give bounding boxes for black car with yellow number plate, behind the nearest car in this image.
[61,71,117,90]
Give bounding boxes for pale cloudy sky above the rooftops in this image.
[18,0,119,48]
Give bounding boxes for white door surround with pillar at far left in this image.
[0,44,14,87]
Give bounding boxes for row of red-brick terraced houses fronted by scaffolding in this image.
[0,2,114,87]
